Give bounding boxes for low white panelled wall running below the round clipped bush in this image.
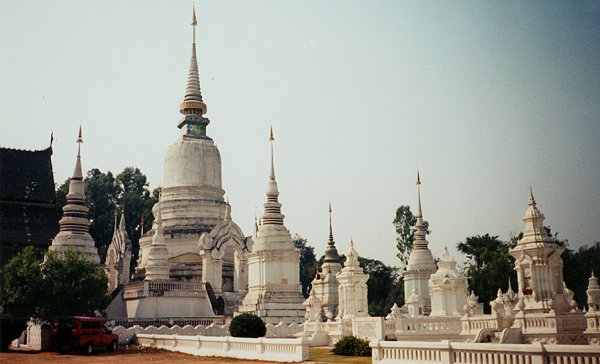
[137,334,308,362]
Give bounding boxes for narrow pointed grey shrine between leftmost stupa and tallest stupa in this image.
[105,207,131,292]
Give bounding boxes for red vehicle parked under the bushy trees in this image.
[51,316,119,354]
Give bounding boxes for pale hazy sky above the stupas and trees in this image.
[0,0,600,265]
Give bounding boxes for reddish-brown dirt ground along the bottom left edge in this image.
[0,346,282,364]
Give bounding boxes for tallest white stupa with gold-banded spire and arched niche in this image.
[117,10,251,317]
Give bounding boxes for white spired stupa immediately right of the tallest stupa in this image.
[239,129,305,324]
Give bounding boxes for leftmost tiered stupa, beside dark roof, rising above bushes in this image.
[49,127,100,264]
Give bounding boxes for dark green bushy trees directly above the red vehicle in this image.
[2,246,110,318]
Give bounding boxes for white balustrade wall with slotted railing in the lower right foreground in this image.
[370,341,600,364]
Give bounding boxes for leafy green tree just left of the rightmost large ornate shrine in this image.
[458,234,517,313]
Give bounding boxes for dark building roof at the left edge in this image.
[0,147,58,265]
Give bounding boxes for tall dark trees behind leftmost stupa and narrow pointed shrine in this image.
[56,167,158,265]
